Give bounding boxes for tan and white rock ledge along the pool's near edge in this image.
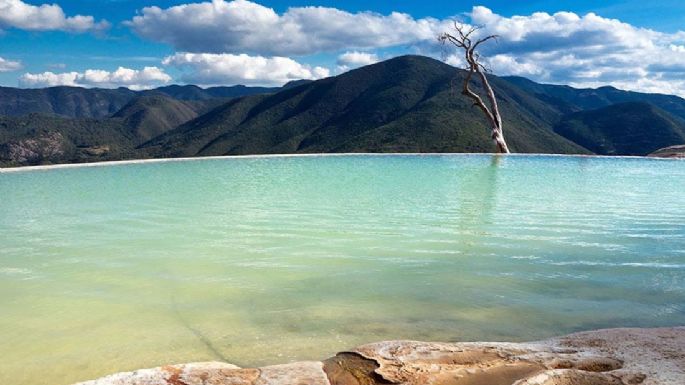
[79,327,685,385]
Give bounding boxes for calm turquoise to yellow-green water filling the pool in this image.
[0,155,685,385]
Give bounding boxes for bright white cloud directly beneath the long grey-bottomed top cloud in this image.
[162,52,330,86]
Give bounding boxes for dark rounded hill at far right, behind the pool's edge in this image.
[554,102,685,155]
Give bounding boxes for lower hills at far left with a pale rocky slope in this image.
[0,93,224,165]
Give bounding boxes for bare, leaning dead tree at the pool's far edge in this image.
[438,23,509,154]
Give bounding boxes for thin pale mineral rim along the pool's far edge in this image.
[0,152,685,174]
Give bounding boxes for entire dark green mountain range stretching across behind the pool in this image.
[0,56,685,166]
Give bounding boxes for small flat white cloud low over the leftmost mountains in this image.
[19,67,171,90]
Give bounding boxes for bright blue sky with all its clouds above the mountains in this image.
[0,0,685,96]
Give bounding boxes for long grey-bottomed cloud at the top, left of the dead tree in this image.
[126,0,449,56]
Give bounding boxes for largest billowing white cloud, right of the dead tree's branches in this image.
[438,6,685,96]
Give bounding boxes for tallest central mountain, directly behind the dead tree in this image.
[141,56,588,157]
